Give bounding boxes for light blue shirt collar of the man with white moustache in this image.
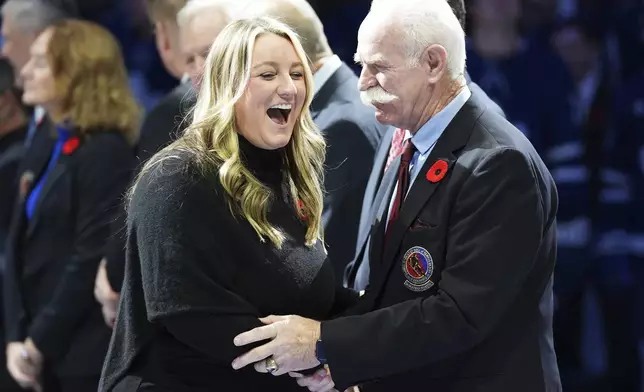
[411,86,472,155]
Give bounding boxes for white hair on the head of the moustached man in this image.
[367,0,466,79]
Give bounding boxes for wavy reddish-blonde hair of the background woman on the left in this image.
[47,19,141,143]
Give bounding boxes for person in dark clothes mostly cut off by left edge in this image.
[0,56,28,392]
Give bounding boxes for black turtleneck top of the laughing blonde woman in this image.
[99,137,356,392]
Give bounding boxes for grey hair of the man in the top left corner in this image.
[2,0,66,34]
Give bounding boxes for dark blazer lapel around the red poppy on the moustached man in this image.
[372,96,484,300]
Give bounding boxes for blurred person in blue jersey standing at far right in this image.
[548,14,640,392]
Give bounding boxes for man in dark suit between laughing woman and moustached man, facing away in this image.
[237,0,387,278]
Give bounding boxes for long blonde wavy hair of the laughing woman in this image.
[136,17,326,248]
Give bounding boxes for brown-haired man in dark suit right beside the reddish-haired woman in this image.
[94,0,194,326]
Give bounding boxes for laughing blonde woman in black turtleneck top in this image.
[99,18,357,392]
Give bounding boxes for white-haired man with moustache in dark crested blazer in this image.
[232,0,561,392]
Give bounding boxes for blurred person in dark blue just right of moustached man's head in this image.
[467,0,573,155]
